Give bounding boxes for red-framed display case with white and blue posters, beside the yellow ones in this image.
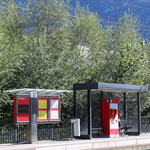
[49,98,60,121]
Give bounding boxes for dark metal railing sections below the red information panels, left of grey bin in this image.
[0,123,71,144]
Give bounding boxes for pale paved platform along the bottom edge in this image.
[0,134,150,150]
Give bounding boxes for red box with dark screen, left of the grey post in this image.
[14,96,30,123]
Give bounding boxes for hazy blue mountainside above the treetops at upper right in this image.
[71,0,150,38]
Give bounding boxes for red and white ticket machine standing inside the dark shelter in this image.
[102,99,119,137]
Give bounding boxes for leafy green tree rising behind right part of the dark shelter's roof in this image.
[104,13,148,85]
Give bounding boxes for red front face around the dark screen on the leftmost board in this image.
[17,97,29,122]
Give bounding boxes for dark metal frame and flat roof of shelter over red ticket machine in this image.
[73,82,148,139]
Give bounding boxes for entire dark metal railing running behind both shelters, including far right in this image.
[0,116,150,144]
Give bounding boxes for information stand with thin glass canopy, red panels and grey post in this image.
[6,88,72,143]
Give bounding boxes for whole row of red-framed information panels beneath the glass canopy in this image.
[14,96,60,123]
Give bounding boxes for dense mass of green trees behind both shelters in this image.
[0,0,150,122]
